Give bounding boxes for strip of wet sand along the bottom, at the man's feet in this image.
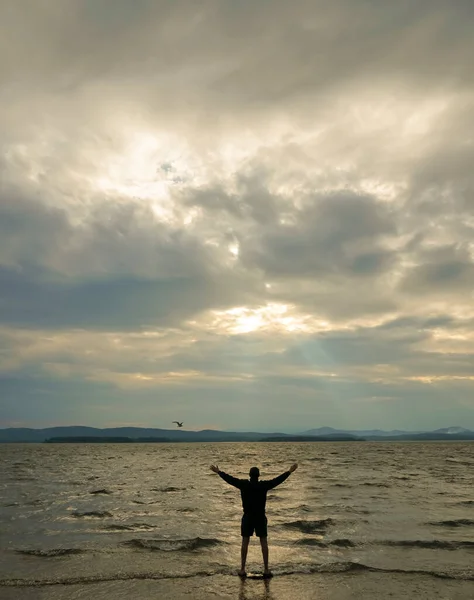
[0,573,474,600]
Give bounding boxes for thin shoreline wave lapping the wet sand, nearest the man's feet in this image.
[0,561,474,587]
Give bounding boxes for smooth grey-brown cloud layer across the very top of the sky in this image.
[0,0,474,106]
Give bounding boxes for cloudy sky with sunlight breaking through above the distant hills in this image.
[0,0,474,432]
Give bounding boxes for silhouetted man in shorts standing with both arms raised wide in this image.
[211,463,298,577]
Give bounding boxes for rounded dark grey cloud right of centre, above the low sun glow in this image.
[242,192,396,278]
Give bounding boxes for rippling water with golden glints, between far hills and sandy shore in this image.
[0,443,474,598]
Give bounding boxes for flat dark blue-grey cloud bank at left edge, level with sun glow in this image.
[0,270,228,330]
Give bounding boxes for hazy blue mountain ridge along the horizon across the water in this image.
[0,425,474,443]
